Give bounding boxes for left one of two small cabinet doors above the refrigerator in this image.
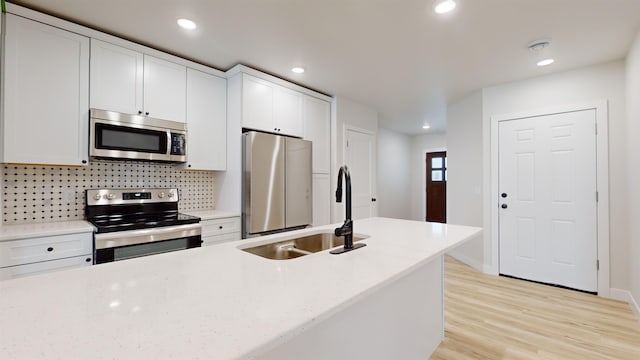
[242,74,275,132]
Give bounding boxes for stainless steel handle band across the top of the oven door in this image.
[95,224,202,250]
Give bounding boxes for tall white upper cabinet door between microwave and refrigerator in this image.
[187,69,227,170]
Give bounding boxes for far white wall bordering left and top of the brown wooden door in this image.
[409,133,448,221]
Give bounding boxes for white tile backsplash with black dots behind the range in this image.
[1,161,215,224]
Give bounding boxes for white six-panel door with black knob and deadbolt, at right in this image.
[498,109,598,292]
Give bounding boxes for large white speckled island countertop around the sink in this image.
[0,218,482,359]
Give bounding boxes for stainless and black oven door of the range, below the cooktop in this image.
[94,224,202,264]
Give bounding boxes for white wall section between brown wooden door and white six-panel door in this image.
[447,91,485,271]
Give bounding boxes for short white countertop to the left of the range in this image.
[0,220,94,242]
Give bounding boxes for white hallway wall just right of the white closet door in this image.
[377,128,412,219]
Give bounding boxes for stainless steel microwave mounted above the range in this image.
[89,109,187,162]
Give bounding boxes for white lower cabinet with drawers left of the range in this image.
[0,232,93,280]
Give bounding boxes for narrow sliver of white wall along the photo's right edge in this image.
[626,33,640,319]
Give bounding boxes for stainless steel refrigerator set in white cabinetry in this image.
[242,131,313,238]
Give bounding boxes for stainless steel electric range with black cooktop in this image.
[85,188,202,264]
